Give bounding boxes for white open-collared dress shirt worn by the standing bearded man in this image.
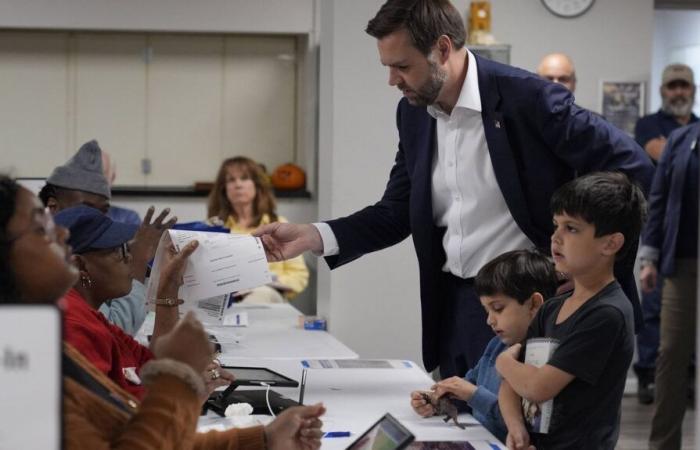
[314,50,533,278]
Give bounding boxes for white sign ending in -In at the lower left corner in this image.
[0,305,63,450]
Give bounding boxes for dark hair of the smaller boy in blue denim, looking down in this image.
[474,249,559,304]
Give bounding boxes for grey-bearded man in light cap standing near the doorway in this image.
[633,64,698,405]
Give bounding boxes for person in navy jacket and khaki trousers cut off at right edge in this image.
[640,123,700,448]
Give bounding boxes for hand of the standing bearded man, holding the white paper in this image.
[253,222,323,261]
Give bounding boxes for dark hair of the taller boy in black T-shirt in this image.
[550,172,647,259]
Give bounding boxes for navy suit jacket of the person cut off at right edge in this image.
[641,124,700,276]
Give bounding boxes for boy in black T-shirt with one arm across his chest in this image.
[496,173,646,450]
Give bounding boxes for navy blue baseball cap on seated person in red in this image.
[54,205,138,254]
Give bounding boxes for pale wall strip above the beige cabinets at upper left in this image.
[0,0,316,33]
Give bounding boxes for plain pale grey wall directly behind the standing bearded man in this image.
[318,0,653,368]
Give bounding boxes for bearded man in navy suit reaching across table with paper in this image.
[256,0,653,377]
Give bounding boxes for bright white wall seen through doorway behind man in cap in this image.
[649,10,700,115]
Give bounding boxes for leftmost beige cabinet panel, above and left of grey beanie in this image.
[0,32,73,177]
